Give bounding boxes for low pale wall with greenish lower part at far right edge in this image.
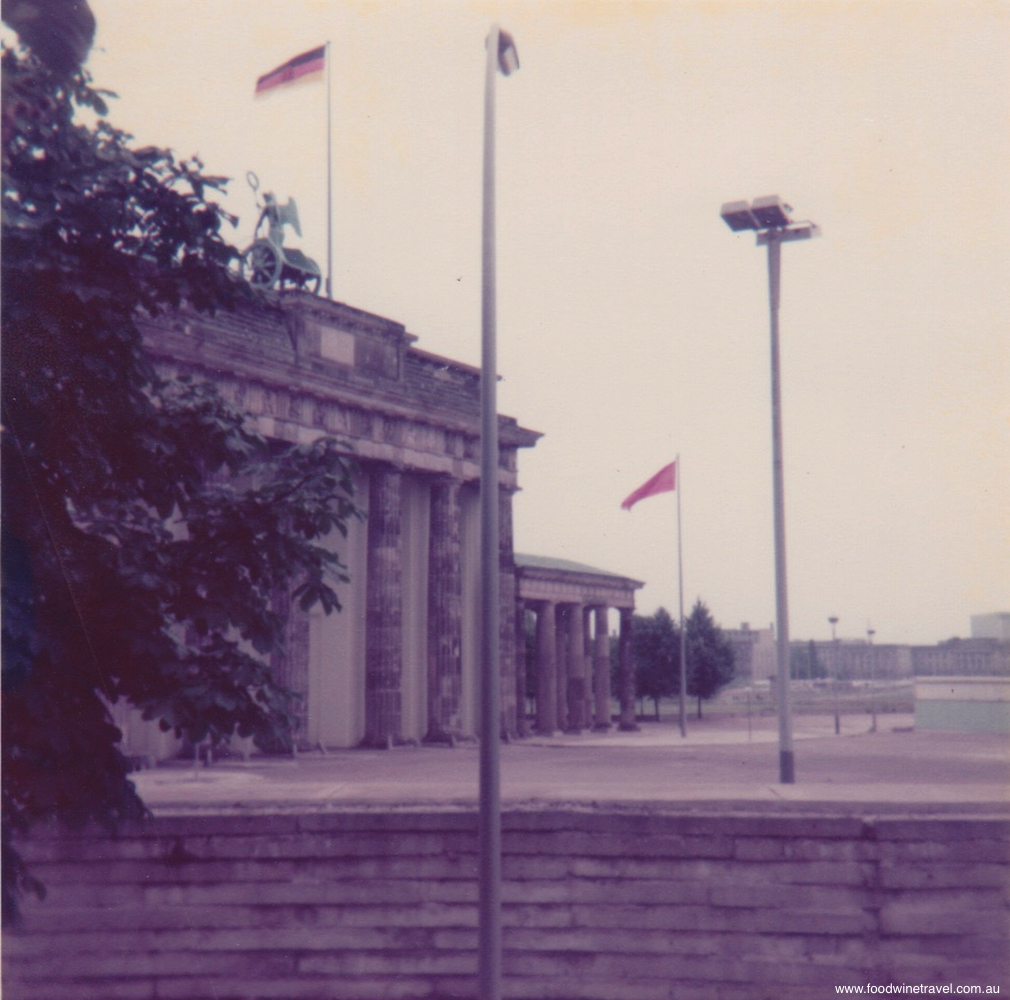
[915,677,1010,732]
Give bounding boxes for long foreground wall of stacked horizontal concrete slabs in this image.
[4,809,1010,1000]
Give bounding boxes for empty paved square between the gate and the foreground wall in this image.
[136,715,1010,814]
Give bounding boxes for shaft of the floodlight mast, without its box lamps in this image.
[768,229,796,785]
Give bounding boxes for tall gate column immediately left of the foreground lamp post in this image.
[424,479,463,745]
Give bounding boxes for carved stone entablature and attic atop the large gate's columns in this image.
[143,299,539,489]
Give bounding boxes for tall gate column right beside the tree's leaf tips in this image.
[365,465,403,746]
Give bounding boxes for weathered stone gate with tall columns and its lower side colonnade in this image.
[128,293,640,756]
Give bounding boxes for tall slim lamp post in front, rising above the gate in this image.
[478,24,519,1000]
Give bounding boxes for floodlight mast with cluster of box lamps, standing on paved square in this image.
[721,195,819,785]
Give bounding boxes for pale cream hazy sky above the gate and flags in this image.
[49,0,1010,643]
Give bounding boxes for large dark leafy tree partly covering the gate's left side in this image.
[0,39,360,916]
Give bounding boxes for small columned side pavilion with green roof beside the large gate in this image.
[515,555,643,735]
